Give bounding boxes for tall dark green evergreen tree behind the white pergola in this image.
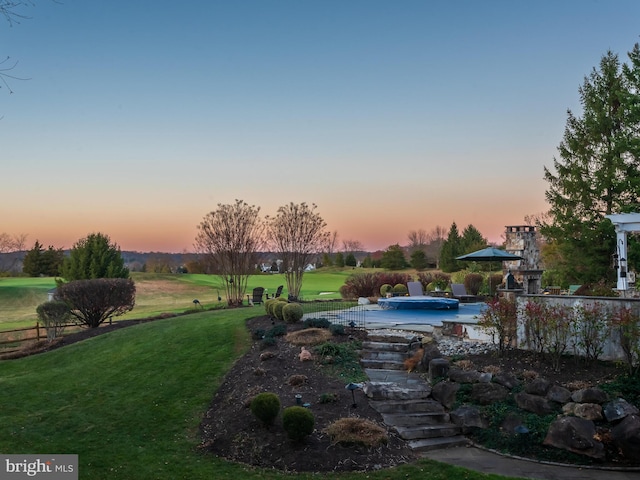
[540,45,640,284]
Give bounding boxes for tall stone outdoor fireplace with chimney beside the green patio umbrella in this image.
[504,225,543,295]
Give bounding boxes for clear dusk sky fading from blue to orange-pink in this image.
[0,0,640,252]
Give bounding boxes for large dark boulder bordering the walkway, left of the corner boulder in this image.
[542,417,605,460]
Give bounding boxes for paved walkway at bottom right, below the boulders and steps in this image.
[422,447,640,480]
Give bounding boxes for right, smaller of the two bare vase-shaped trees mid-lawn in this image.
[267,203,330,298]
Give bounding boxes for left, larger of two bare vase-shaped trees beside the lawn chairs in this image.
[195,200,264,306]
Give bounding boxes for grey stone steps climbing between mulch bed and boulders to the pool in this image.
[360,332,467,452]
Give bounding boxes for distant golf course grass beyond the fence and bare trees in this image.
[0,269,363,331]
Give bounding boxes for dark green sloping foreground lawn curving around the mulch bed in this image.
[0,309,516,480]
